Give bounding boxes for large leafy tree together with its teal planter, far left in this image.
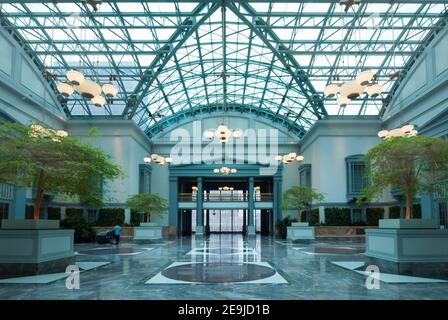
[0,122,121,275]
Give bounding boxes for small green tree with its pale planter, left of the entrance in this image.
[126,193,168,240]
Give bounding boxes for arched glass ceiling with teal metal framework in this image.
[0,0,448,135]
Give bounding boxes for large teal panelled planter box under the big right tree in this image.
[365,229,448,263]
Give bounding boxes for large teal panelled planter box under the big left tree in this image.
[0,229,74,277]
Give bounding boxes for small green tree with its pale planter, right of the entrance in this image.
[281,185,325,240]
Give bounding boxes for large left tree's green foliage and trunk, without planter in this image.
[0,122,122,220]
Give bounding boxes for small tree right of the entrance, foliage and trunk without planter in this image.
[282,185,325,222]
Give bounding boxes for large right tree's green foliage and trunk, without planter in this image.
[358,136,448,220]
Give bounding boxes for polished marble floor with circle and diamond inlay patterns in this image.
[0,234,448,300]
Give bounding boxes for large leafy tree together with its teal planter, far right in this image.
[363,136,448,266]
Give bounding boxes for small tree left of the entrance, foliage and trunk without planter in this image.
[126,193,168,222]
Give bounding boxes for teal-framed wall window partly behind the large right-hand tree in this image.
[345,155,368,198]
